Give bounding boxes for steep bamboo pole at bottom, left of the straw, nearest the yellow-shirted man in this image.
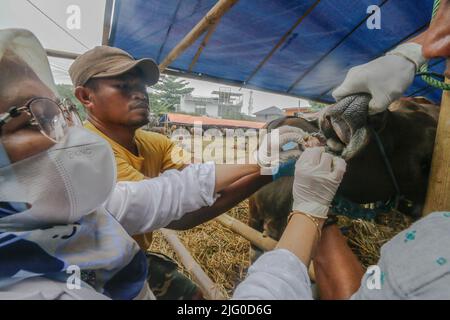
[161,229,225,300]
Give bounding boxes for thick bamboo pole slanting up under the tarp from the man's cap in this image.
[159,0,238,72]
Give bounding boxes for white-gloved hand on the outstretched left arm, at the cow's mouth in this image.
[255,126,307,168]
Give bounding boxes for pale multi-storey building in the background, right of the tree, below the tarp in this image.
[177,88,243,118]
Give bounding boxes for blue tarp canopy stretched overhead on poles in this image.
[109,0,445,102]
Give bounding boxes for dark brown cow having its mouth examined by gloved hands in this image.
[249,97,439,240]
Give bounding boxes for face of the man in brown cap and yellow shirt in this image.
[88,69,149,128]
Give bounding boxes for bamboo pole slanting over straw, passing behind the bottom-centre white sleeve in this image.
[215,214,316,281]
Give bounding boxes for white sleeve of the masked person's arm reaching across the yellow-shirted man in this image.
[104,162,215,235]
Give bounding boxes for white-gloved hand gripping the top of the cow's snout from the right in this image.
[333,42,426,115]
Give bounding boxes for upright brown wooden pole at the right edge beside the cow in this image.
[423,73,450,216]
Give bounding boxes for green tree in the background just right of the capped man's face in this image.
[149,75,194,114]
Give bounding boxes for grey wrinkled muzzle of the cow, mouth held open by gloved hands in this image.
[319,94,371,160]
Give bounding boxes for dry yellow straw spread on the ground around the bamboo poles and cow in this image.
[151,201,412,297]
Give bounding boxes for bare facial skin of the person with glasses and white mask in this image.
[0,56,55,163]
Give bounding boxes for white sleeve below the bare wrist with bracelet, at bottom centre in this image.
[233,249,312,300]
